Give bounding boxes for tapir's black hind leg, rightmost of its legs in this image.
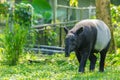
[99,42,110,72]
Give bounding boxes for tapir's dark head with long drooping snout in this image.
[64,27,83,57]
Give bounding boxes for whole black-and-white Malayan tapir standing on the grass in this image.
[64,19,111,72]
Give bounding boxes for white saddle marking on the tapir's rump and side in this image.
[92,20,111,51]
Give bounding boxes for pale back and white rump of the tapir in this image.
[74,19,111,51]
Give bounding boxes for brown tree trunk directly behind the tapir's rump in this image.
[96,0,116,52]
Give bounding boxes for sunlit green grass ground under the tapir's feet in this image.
[0,54,120,80]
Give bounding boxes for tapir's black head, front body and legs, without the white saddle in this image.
[65,19,110,72]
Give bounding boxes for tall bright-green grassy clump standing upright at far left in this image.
[3,24,29,65]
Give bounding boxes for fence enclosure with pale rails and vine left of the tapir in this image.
[33,0,95,47]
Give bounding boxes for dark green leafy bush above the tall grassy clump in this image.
[14,3,33,27]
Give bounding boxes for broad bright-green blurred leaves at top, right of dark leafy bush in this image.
[22,0,52,24]
